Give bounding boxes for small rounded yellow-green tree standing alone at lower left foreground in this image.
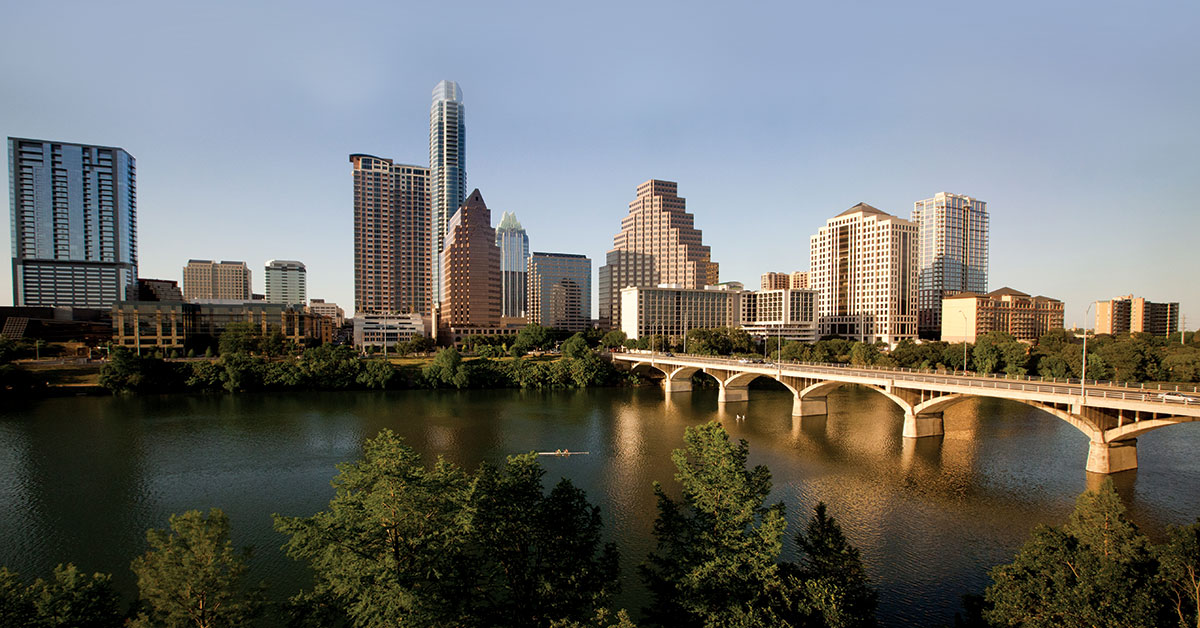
[130,508,260,628]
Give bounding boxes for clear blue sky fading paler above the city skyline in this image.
[0,0,1200,329]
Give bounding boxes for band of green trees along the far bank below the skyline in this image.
[0,323,1200,395]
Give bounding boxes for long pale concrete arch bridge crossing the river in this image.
[612,353,1200,473]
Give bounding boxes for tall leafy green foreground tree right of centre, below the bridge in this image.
[641,423,787,627]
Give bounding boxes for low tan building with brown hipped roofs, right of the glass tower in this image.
[941,288,1063,342]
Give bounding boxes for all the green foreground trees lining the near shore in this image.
[0,421,1200,628]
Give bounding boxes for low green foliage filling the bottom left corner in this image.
[0,564,125,628]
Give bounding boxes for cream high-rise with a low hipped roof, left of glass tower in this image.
[809,203,917,345]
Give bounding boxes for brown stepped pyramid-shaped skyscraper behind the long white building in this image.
[600,179,719,328]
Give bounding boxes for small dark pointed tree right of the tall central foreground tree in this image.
[787,503,878,628]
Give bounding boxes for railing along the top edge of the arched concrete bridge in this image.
[619,353,1200,406]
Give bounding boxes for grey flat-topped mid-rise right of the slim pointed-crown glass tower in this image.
[528,252,592,331]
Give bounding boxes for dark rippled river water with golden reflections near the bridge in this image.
[0,388,1200,626]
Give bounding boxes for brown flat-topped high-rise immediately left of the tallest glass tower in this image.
[350,154,433,316]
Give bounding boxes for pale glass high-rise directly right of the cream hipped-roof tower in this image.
[912,192,988,339]
